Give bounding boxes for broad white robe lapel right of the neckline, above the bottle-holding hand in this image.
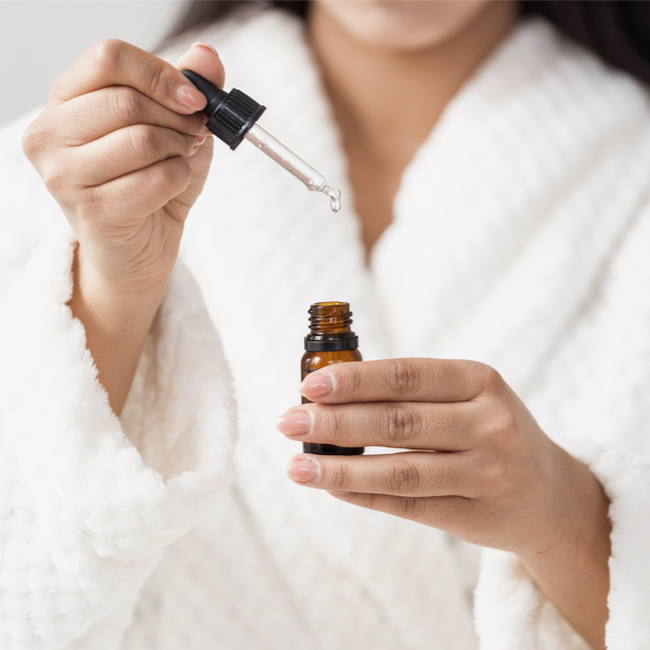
[373,21,647,393]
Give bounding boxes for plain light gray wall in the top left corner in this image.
[0,0,184,126]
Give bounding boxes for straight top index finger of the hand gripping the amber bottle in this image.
[300,359,498,404]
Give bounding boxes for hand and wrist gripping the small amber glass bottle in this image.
[277,359,610,648]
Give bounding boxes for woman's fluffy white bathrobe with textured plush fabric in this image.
[0,12,650,650]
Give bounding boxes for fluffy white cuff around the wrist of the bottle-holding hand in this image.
[475,443,650,650]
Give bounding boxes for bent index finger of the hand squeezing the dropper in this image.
[48,39,210,113]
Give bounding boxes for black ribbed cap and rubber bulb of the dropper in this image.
[181,70,266,151]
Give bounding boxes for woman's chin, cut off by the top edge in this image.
[316,0,498,51]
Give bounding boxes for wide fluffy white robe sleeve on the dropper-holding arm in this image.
[0,221,236,650]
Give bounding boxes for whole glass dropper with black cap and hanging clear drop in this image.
[177,70,341,212]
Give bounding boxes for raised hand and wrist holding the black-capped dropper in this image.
[23,40,224,414]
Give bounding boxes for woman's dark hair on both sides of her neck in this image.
[164,0,650,84]
